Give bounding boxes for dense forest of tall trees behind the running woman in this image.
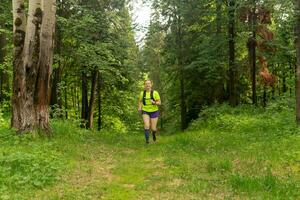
[0,0,300,132]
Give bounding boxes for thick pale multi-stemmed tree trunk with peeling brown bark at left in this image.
[12,0,56,132]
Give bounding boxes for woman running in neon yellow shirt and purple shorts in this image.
[138,80,161,144]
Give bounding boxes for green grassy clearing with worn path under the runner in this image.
[0,100,300,200]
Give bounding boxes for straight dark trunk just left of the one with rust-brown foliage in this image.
[228,0,239,106]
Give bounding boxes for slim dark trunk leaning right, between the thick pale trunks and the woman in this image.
[88,70,99,129]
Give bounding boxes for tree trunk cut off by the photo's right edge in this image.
[295,0,300,125]
